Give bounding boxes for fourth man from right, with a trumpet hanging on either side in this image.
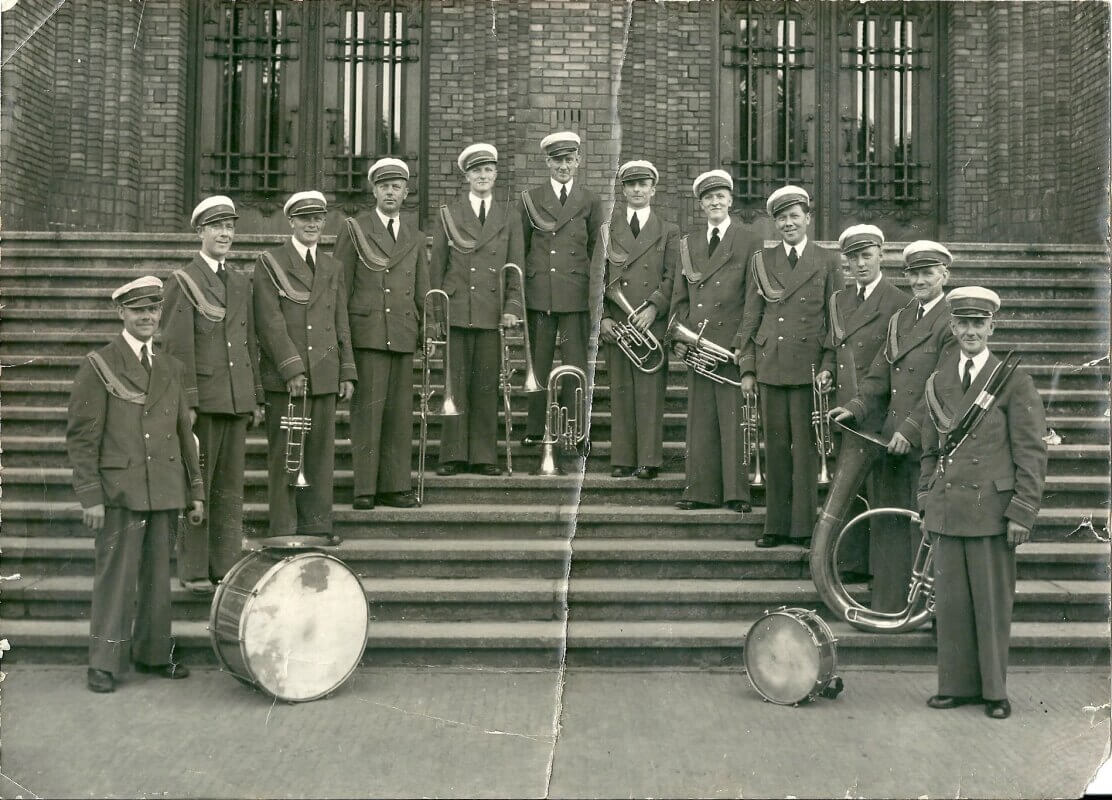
[738,186,842,547]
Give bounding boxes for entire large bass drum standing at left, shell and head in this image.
[209,550,370,702]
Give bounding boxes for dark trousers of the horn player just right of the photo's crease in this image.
[606,345,668,467]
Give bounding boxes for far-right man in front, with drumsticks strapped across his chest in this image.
[915,286,1046,720]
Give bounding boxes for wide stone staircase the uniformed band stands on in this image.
[0,233,1109,665]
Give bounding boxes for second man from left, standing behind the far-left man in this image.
[162,195,266,594]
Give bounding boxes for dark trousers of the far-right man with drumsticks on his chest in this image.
[933,535,1015,700]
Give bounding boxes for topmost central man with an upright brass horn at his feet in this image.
[520,131,603,456]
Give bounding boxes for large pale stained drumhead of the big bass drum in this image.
[240,553,368,701]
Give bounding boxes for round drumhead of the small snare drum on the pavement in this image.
[745,611,822,705]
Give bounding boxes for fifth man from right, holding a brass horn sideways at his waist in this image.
[669,169,758,513]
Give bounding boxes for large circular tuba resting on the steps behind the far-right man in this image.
[810,422,934,633]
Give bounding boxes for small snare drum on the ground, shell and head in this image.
[745,608,841,705]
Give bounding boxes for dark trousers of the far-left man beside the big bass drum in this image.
[89,506,179,675]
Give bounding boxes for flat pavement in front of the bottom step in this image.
[0,663,1110,798]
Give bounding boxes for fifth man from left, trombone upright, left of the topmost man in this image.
[430,144,525,475]
